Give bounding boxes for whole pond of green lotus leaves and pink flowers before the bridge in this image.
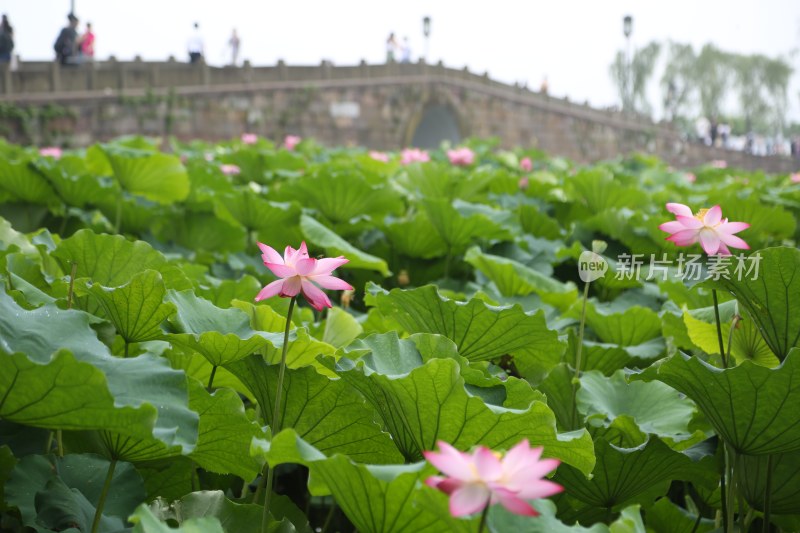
[0,135,800,533]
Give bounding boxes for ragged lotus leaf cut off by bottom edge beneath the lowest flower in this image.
[487,500,648,533]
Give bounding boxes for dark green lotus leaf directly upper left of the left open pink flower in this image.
[158,212,247,252]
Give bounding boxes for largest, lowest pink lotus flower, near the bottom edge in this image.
[424,439,564,516]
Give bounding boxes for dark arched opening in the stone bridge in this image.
[403,89,467,149]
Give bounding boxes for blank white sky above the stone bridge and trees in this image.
[0,0,800,120]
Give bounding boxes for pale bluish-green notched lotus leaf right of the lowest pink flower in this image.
[578,370,702,441]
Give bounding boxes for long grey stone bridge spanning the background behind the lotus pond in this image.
[0,60,793,172]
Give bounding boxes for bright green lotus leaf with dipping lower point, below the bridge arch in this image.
[422,198,510,254]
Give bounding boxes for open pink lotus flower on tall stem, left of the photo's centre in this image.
[256,242,353,311]
